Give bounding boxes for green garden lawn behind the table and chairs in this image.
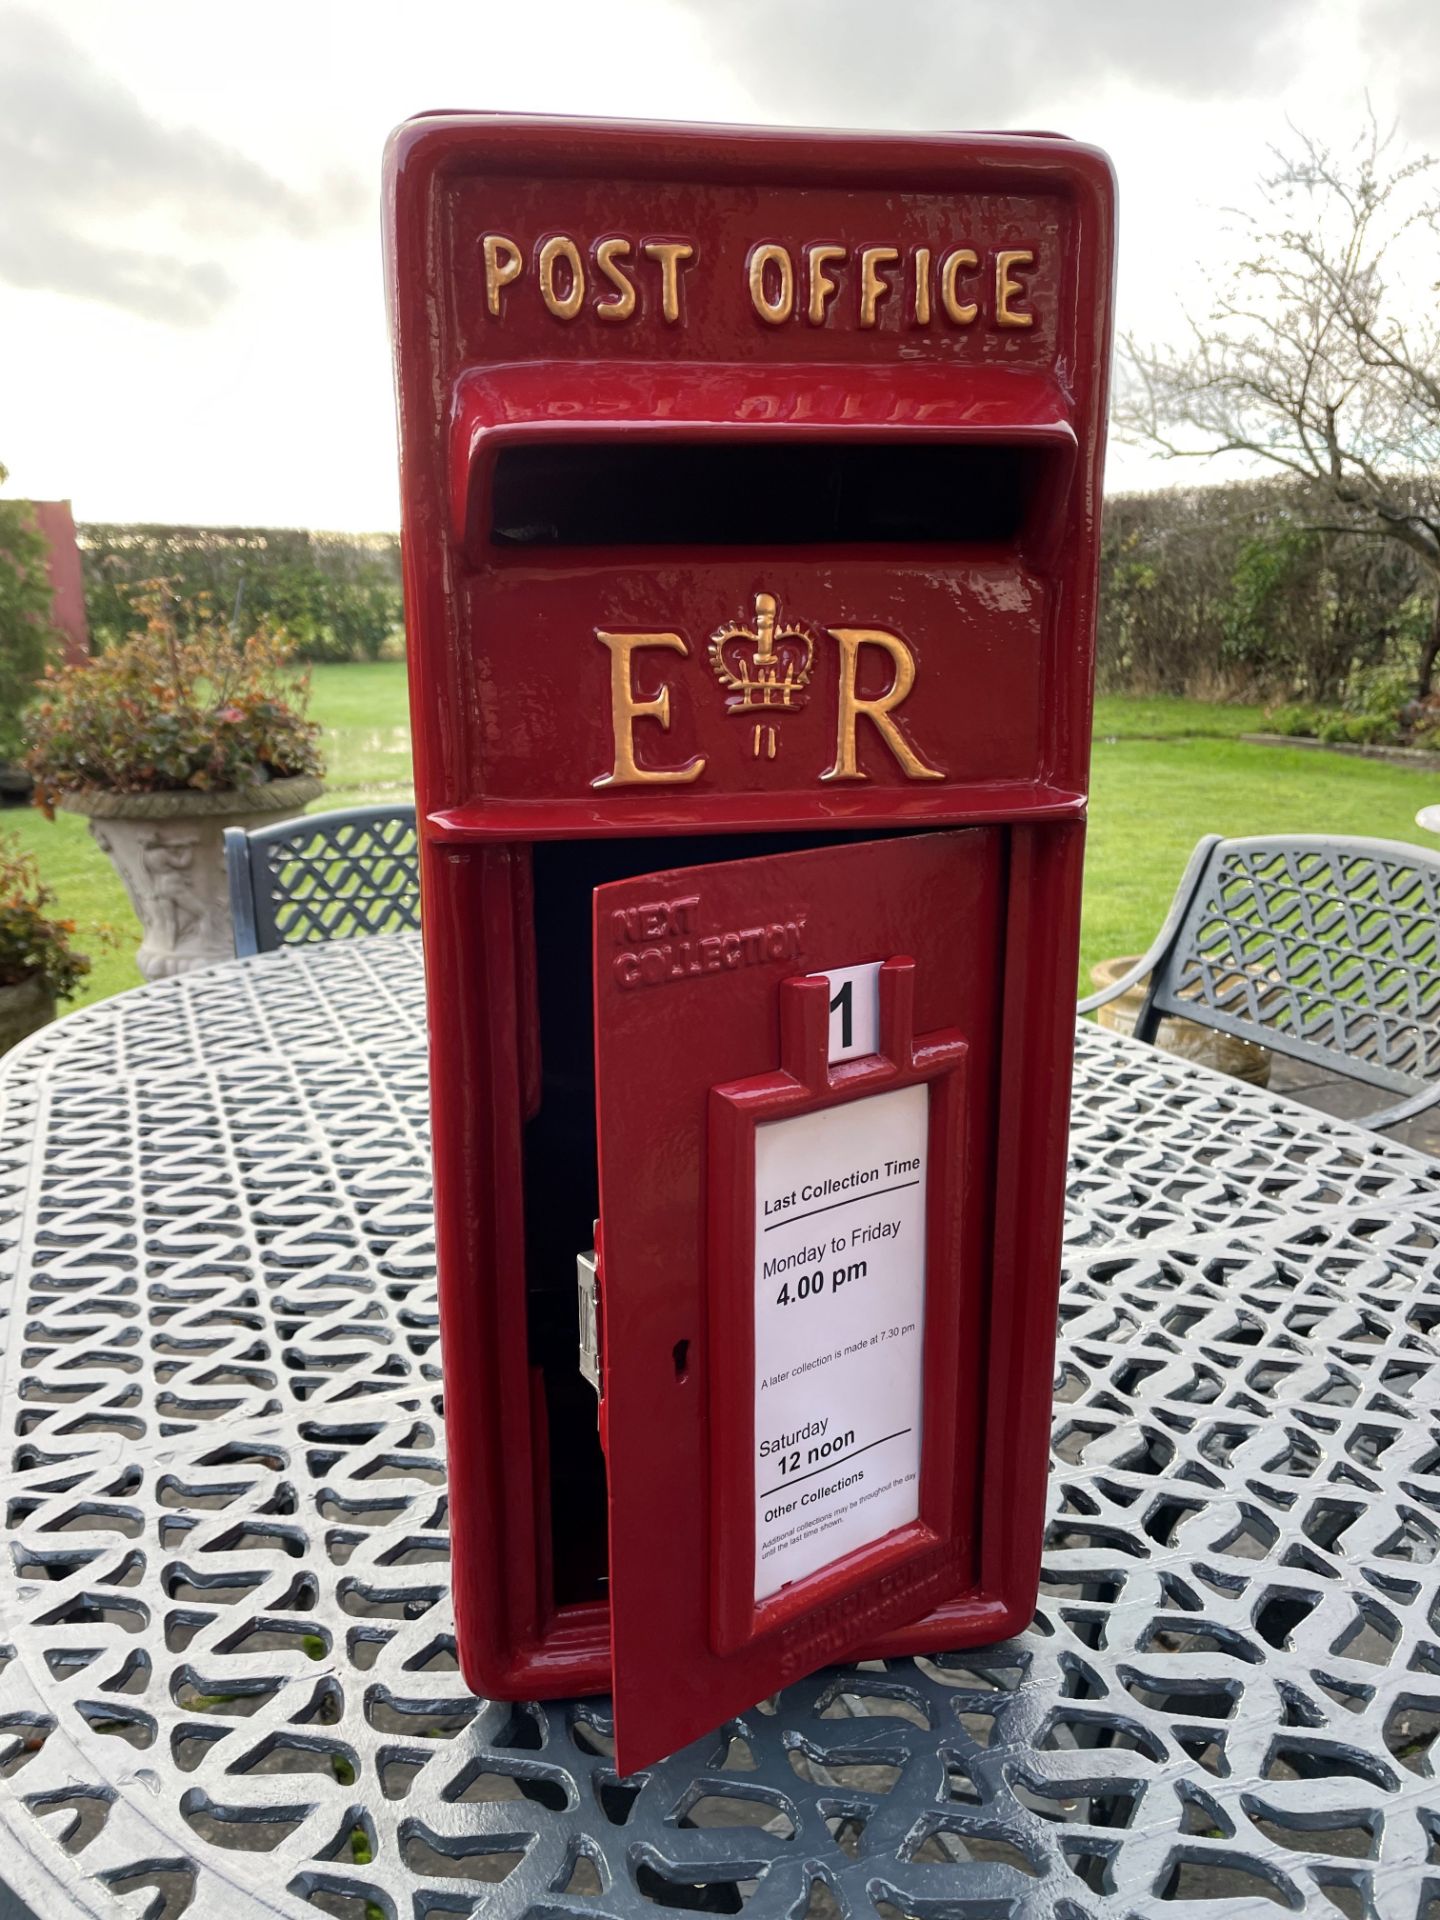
[0,662,1440,1000]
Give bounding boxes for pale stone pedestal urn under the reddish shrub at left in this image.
[58,774,323,979]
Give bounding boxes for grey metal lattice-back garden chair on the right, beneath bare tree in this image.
[1077,833,1440,1127]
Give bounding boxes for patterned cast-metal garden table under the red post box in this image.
[0,935,1440,1920]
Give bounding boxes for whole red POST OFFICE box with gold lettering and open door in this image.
[386,115,1114,1770]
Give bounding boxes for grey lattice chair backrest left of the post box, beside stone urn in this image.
[225,806,420,956]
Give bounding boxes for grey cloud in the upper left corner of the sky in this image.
[0,6,365,326]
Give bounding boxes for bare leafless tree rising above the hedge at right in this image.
[1117,123,1440,693]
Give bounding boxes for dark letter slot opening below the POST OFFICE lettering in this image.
[490,438,1068,549]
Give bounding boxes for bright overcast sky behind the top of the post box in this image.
[0,0,1440,530]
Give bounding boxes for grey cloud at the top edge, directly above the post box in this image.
[680,0,1308,127]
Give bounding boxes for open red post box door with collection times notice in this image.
[595,828,1006,1772]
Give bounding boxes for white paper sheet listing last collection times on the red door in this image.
[755,1082,929,1601]
